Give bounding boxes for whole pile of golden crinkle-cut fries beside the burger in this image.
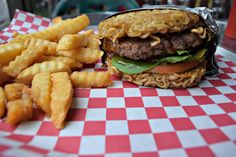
[0,15,111,129]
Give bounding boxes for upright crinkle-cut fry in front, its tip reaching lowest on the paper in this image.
[50,72,73,129]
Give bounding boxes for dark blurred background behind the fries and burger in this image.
[0,0,233,47]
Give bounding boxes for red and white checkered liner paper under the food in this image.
[0,10,236,157]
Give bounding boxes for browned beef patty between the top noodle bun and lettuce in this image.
[103,32,204,60]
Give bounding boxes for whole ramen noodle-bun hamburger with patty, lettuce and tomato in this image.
[98,8,216,88]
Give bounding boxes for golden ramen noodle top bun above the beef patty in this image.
[98,9,200,41]
